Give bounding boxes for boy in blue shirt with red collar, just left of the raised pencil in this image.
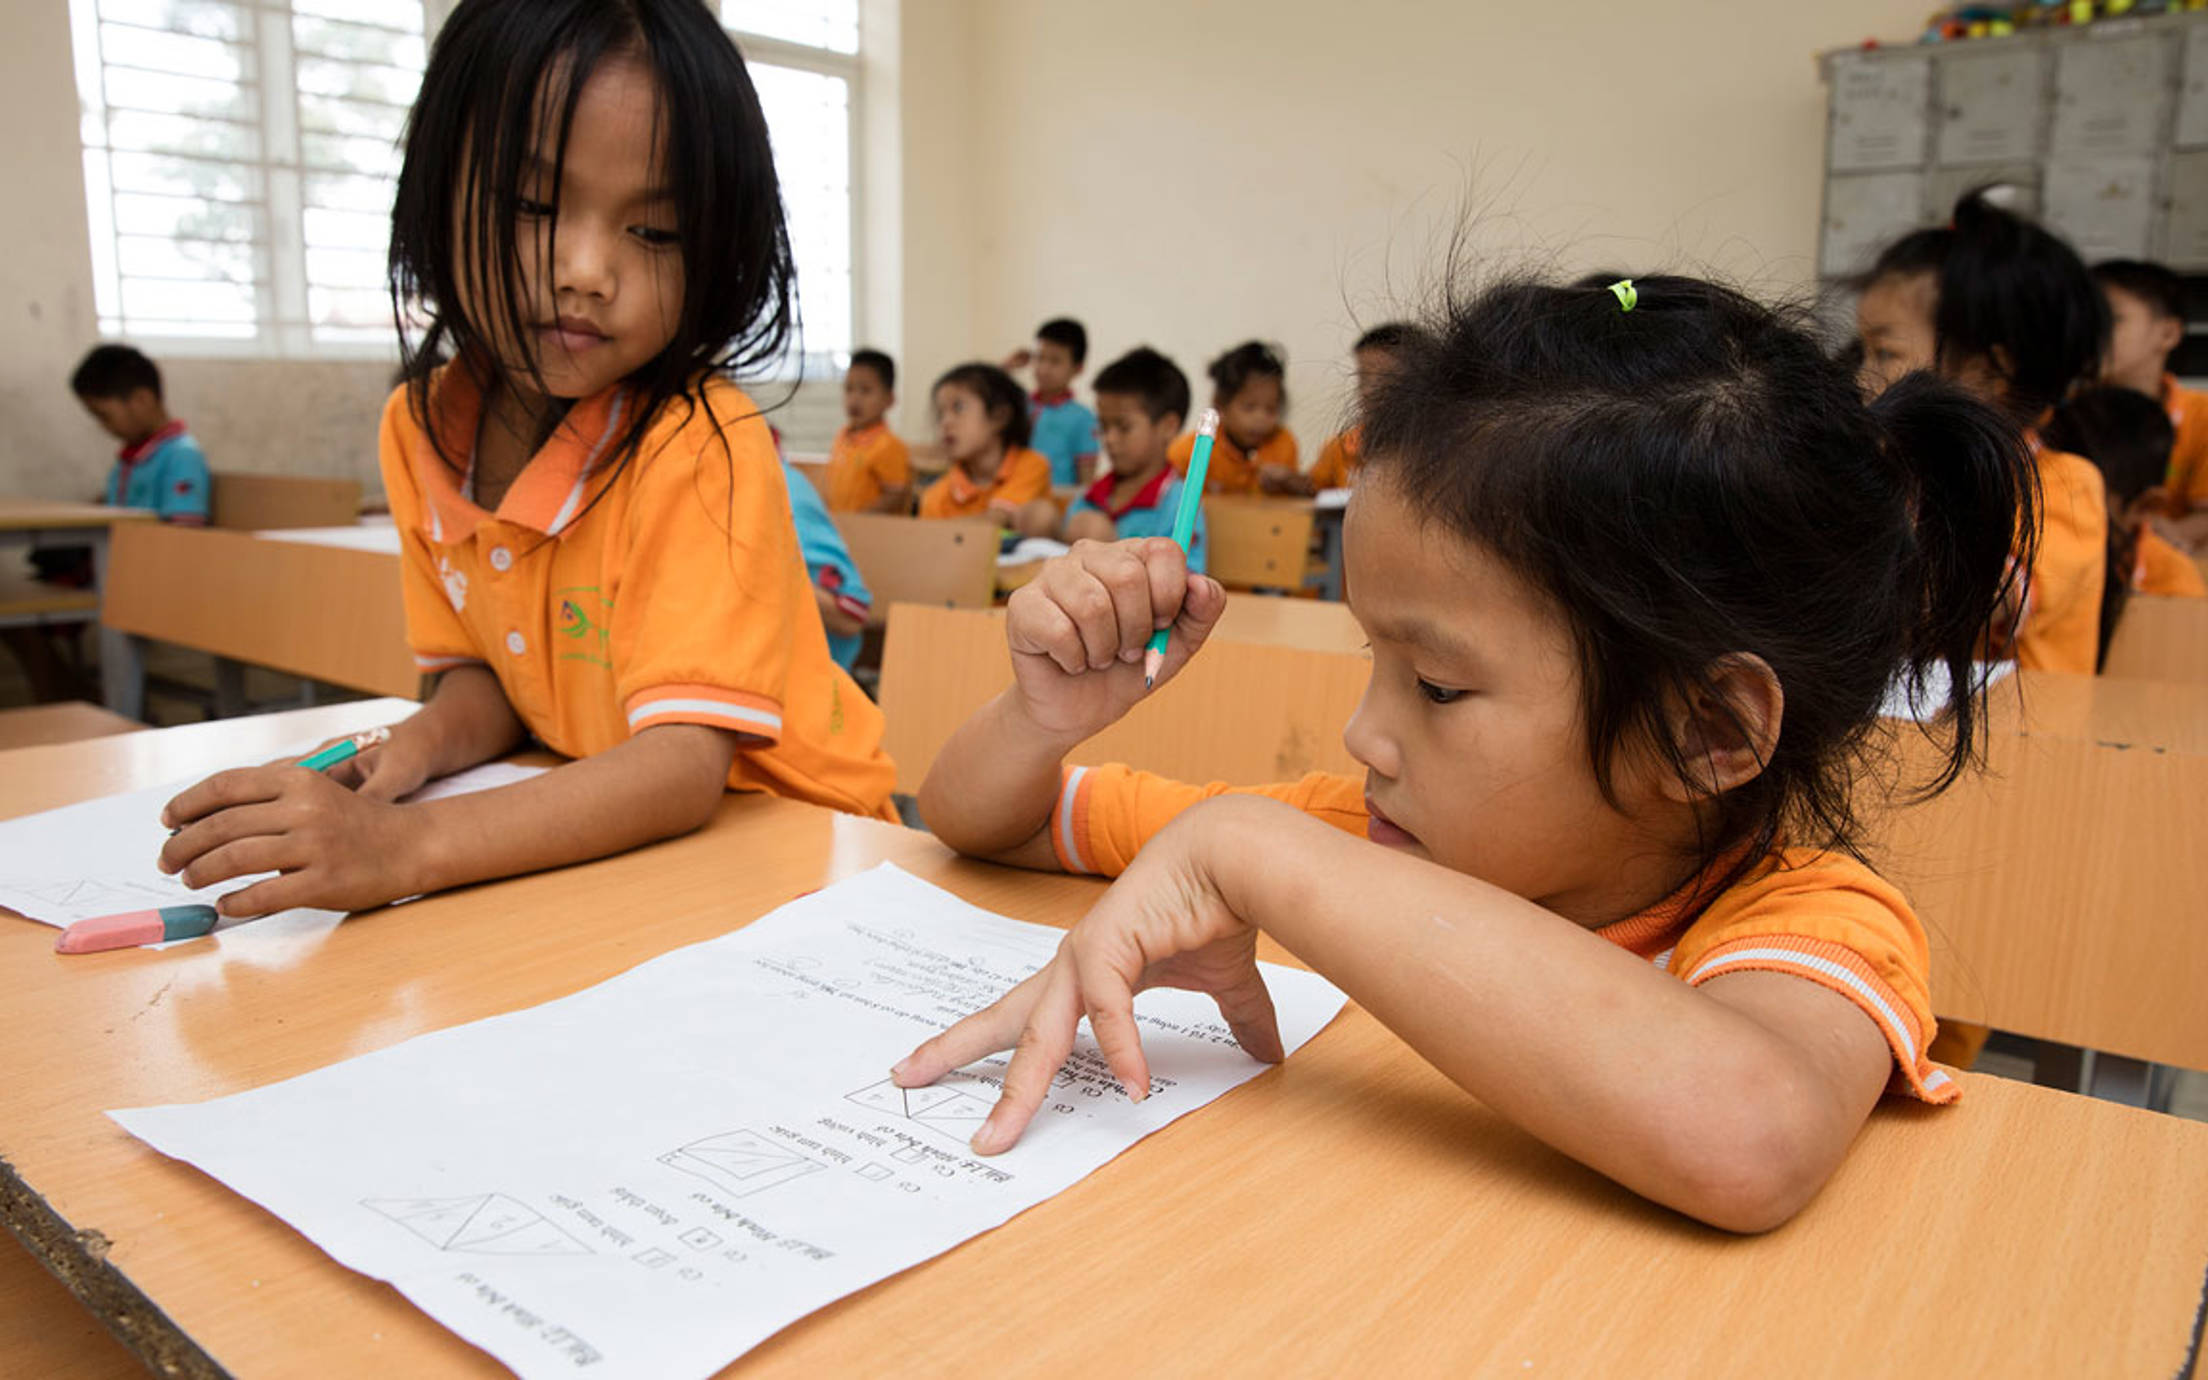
[1022,344,1203,572]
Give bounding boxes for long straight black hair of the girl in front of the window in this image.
[389,0,795,468]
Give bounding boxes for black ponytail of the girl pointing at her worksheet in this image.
[1868,373,2040,795]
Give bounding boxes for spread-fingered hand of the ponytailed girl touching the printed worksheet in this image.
[890,797,1283,1155]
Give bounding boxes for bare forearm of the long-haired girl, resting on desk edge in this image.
[406,724,735,892]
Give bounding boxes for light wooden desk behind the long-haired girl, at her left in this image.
[104,526,422,710]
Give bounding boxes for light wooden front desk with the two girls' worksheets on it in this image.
[0,711,2208,1380]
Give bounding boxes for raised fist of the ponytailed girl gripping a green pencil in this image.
[1005,537,1228,740]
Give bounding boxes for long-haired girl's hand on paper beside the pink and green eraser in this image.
[161,763,424,916]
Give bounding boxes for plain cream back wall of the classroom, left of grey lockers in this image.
[905,0,1925,443]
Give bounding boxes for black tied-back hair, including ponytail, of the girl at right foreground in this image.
[1362,276,2031,887]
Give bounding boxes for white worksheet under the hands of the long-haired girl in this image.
[0,742,545,927]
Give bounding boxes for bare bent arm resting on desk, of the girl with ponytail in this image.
[1203,802,1890,1230]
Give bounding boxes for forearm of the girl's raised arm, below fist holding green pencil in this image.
[921,689,1075,870]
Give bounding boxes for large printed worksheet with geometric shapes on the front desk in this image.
[110,863,1342,1380]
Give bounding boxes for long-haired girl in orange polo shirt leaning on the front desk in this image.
[161,0,894,914]
